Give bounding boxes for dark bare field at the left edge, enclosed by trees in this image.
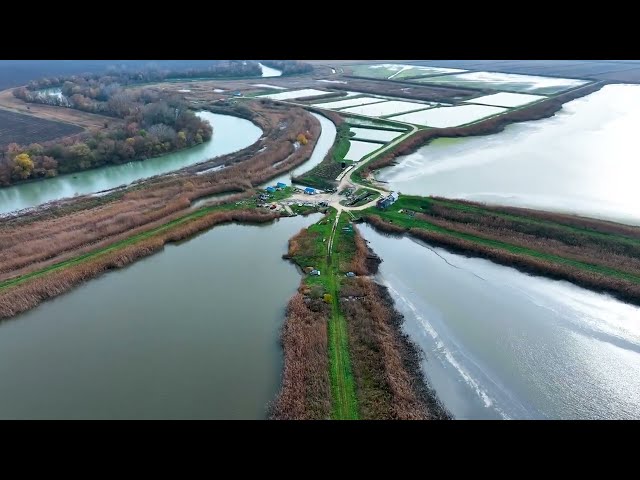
[0,110,83,147]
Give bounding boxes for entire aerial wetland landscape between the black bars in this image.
[0,60,640,421]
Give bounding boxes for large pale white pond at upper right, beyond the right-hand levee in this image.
[379,85,640,224]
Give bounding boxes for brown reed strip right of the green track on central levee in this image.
[332,213,449,419]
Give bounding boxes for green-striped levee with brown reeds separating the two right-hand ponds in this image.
[363,196,640,303]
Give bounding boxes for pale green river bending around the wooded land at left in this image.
[0,112,262,214]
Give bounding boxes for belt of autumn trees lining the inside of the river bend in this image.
[0,77,213,186]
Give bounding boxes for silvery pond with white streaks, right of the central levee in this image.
[360,225,640,419]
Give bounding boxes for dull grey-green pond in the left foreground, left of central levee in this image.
[0,215,319,419]
